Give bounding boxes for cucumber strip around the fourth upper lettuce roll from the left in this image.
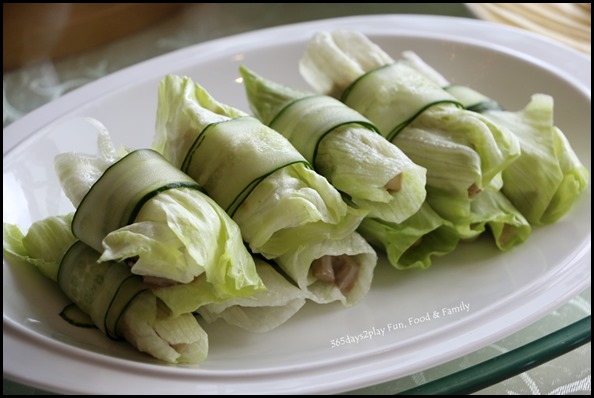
[341,62,463,141]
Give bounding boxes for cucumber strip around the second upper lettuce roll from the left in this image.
[182,117,311,217]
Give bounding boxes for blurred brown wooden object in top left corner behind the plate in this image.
[2,3,181,70]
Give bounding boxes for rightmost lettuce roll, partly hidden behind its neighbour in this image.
[403,51,590,225]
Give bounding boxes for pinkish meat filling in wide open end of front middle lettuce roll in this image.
[312,254,359,294]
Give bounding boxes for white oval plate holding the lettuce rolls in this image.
[3,15,591,395]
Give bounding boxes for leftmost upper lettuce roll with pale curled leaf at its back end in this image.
[55,120,265,304]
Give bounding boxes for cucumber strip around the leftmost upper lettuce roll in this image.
[72,149,202,252]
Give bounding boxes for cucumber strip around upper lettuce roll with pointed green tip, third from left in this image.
[269,95,379,164]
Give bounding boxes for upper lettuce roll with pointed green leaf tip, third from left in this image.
[240,66,426,223]
